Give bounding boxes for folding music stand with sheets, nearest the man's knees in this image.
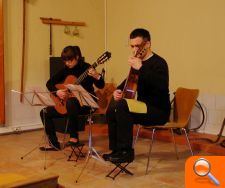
[66,84,106,183]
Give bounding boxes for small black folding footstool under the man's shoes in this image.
[106,163,134,180]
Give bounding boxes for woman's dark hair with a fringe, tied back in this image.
[61,46,83,61]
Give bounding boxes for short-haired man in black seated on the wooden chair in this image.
[103,29,171,163]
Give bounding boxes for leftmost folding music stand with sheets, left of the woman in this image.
[11,87,67,170]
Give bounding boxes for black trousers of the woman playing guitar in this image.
[40,97,90,146]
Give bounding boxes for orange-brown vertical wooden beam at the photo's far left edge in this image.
[0,0,5,125]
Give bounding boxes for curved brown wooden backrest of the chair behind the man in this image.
[173,87,199,127]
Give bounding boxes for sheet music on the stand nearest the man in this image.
[65,84,99,108]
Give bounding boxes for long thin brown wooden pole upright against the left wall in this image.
[20,0,26,103]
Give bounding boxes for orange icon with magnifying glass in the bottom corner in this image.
[185,156,225,188]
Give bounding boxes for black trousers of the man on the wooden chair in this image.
[106,99,169,151]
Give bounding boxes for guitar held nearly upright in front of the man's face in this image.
[123,43,146,99]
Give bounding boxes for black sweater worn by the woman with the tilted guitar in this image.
[46,61,105,95]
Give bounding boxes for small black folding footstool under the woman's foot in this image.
[67,142,85,162]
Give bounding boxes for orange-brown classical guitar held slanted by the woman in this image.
[50,51,111,114]
